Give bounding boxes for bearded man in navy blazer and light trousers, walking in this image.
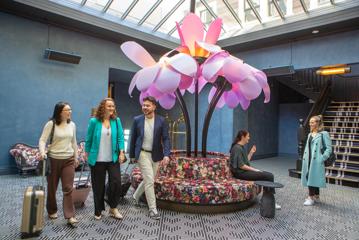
[130,97,171,220]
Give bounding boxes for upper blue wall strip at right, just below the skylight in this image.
[236,30,359,69]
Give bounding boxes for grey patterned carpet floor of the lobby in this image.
[0,157,359,240]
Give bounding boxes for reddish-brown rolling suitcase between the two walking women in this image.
[72,163,91,207]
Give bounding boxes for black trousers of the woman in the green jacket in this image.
[91,162,121,216]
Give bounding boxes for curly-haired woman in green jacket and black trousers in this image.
[85,98,125,220]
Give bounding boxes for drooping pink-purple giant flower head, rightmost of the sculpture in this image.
[202,51,270,109]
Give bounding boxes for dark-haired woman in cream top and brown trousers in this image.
[39,102,78,227]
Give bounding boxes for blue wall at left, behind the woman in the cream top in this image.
[0,12,136,173]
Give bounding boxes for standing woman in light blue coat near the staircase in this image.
[301,115,332,206]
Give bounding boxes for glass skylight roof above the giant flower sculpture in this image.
[49,0,359,40]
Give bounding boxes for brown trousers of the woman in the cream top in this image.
[46,157,75,219]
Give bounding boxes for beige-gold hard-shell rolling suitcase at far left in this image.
[21,159,49,238]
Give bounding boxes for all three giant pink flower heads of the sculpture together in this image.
[121,13,270,109]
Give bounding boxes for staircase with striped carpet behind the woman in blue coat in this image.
[289,102,359,188]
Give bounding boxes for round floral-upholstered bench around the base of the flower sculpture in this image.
[131,151,259,213]
